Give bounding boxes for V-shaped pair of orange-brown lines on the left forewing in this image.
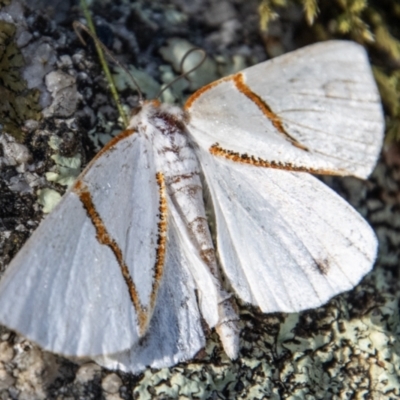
[73,172,167,335]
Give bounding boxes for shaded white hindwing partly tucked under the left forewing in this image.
[95,211,206,373]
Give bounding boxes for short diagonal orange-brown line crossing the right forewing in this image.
[232,73,308,151]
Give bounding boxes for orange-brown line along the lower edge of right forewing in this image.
[209,143,348,175]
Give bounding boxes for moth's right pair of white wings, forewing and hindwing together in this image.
[185,41,384,312]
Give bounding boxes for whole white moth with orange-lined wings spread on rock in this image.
[0,41,383,373]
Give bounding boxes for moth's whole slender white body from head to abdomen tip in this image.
[129,102,239,358]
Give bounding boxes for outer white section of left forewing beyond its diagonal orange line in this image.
[0,192,138,355]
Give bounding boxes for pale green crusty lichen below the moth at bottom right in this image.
[133,260,400,400]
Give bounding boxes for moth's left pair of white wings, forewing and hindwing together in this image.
[0,128,212,372]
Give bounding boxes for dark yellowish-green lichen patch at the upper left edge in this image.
[0,21,41,141]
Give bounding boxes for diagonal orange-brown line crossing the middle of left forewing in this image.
[73,180,149,334]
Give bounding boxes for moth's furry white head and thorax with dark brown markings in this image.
[128,100,199,179]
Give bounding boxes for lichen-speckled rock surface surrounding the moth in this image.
[0,0,400,400]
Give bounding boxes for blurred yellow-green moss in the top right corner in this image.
[259,0,400,141]
